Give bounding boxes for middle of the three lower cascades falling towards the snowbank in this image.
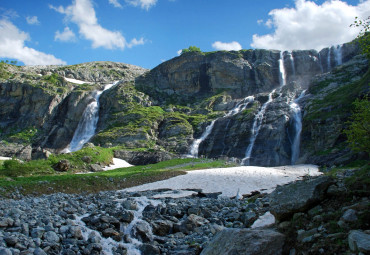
[242,89,275,165]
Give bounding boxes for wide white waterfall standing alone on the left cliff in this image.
[63,81,118,152]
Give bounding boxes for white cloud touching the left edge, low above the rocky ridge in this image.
[0,19,66,65]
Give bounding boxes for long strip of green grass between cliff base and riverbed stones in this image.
[0,159,235,196]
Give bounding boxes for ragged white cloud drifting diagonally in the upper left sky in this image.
[50,0,144,49]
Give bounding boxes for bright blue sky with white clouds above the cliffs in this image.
[0,0,370,68]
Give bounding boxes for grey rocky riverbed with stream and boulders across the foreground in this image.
[0,171,370,255]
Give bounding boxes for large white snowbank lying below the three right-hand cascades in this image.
[125,165,321,197]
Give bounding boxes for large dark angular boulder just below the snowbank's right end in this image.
[269,176,333,221]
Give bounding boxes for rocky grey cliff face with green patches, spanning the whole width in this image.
[0,43,368,166]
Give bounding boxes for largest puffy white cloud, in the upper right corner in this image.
[251,0,370,50]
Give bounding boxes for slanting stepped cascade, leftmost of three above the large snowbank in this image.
[187,96,254,158]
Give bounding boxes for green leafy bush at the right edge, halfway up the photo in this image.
[344,95,370,155]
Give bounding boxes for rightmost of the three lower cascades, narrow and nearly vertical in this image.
[289,90,306,165]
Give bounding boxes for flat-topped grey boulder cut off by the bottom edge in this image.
[201,229,285,255]
